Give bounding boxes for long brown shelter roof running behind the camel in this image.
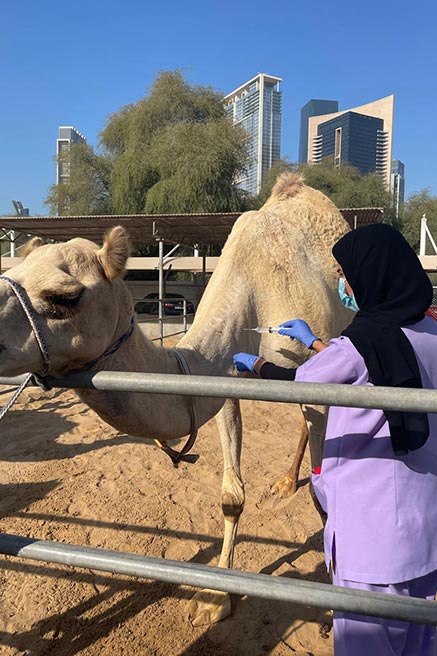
[0,208,382,246]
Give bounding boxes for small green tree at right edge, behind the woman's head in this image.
[401,189,437,255]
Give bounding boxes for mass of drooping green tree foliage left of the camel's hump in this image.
[46,71,247,214]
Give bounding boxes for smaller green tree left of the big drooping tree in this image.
[45,144,112,216]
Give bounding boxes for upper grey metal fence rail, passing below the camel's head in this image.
[0,371,437,413]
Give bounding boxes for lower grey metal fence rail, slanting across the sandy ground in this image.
[0,534,437,625]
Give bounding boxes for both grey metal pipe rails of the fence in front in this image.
[0,371,437,625]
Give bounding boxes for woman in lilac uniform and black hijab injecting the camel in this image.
[234,224,437,656]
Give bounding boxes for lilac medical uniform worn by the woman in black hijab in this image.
[296,317,437,656]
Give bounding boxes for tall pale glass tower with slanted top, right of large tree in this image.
[224,73,282,195]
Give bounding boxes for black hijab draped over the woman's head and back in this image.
[332,223,432,455]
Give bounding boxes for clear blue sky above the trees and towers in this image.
[0,0,437,214]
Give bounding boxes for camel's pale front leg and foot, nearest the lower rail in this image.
[189,399,244,626]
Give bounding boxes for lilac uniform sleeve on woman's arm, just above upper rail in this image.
[295,337,365,384]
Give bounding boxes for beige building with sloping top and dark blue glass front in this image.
[306,95,394,189]
